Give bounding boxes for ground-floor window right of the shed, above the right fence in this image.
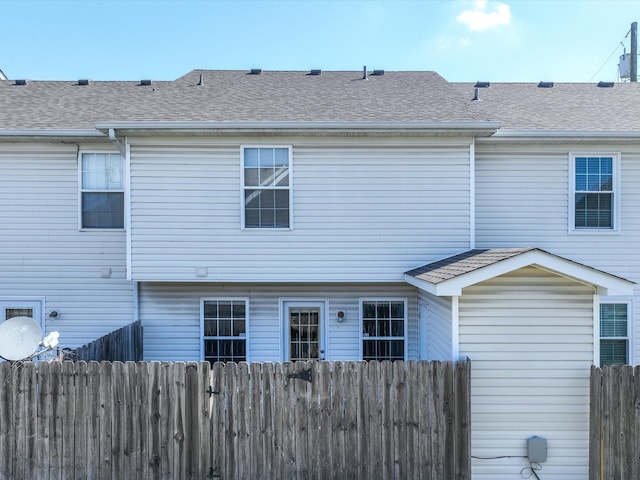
[600,303,629,367]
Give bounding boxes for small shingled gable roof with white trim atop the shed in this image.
[405,248,635,296]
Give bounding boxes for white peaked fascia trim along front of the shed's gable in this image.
[405,250,635,297]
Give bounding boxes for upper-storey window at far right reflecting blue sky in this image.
[571,155,619,230]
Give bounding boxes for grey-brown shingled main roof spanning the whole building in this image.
[0,70,640,133]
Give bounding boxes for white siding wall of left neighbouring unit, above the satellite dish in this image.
[0,144,134,348]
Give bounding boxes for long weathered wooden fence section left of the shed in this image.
[0,361,471,480]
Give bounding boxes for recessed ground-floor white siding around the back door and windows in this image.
[140,283,418,362]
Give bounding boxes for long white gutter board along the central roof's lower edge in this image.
[96,121,500,136]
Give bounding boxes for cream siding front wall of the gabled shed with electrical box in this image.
[460,267,594,480]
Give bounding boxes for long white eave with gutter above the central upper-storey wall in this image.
[96,121,500,137]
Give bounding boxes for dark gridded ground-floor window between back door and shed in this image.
[360,299,407,360]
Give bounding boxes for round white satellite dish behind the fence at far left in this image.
[0,317,42,360]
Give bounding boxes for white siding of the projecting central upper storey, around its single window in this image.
[131,144,470,282]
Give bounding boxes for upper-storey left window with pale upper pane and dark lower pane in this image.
[80,153,124,229]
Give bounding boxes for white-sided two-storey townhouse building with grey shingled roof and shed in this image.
[0,69,640,480]
